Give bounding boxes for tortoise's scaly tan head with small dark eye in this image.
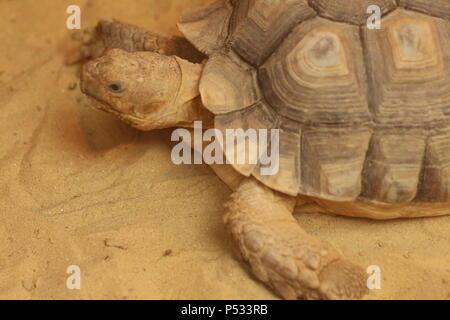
[81,49,198,130]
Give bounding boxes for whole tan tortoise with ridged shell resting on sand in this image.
[74,0,450,299]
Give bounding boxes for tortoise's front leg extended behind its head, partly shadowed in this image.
[67,20,205,64]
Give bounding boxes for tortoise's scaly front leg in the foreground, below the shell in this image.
[225,179,367,299]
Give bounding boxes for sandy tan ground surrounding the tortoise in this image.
[0,0,450,299]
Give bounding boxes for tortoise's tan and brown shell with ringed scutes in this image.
[179,0,450,203]
